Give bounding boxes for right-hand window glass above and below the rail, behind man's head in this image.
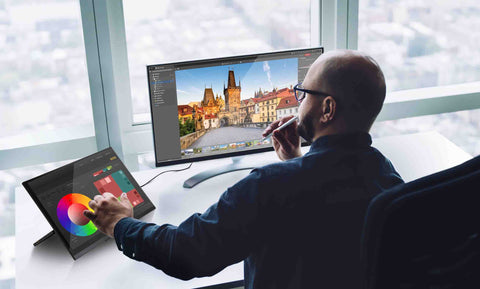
[358,0,480,162]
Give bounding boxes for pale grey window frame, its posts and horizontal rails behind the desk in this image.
[0,0,480,171]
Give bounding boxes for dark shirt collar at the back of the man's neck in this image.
[309,132,372,152]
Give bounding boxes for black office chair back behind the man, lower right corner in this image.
[362,156,480,289]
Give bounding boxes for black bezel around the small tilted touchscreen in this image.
[22,147,155,260]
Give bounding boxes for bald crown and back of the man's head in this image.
[309,50,386,130]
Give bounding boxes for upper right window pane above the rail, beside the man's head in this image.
[358,0,480,91]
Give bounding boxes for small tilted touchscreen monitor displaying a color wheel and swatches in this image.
[23,148,155,259]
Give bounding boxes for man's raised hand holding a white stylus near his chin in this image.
[262,115,302,161]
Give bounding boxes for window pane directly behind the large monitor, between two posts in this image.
[123,0,310,122]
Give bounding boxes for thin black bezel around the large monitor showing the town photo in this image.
[146,46,325,167]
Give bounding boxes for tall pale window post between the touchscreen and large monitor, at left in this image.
[84,0,133,159]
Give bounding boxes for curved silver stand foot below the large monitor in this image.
[183,157,265,189]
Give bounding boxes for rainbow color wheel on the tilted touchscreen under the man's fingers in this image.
[57,194,97,236]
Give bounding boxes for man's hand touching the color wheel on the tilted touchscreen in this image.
[83,193,133,238]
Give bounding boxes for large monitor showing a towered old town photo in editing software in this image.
[147,47,323,166]
